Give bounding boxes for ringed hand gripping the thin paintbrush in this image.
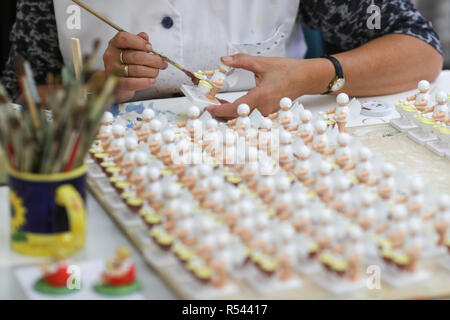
[103,32,167,102]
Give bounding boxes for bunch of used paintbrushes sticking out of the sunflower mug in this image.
[0,42,117,174]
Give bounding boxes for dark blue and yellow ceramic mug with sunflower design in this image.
[8,166,86,257]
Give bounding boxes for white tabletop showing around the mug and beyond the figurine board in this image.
[0,71,450,299]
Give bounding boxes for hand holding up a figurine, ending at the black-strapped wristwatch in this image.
[208,54,334,119]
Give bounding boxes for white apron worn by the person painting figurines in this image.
[53,0,307,100]
